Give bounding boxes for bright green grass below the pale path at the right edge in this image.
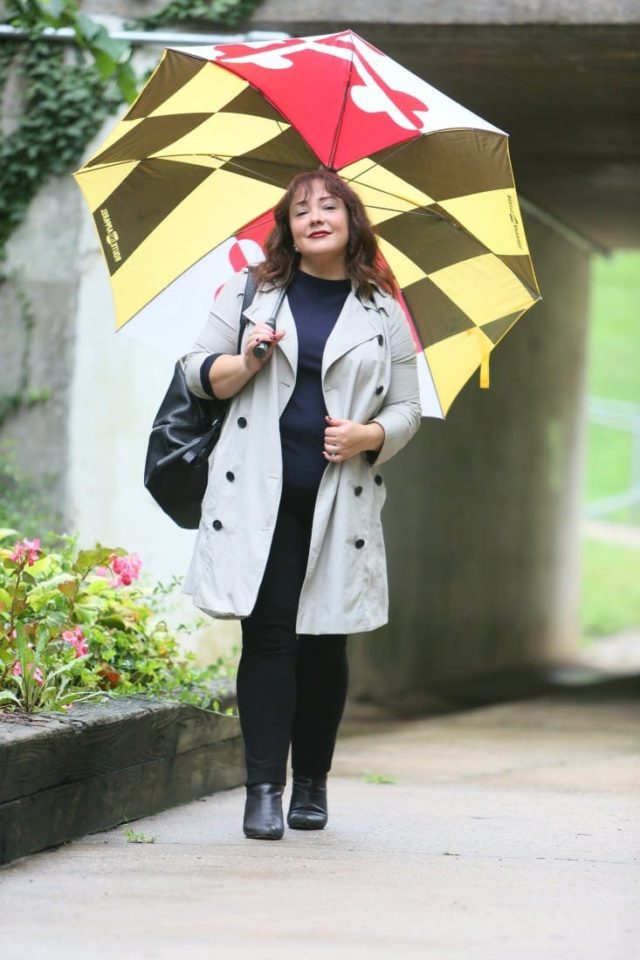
[581,538,640,643]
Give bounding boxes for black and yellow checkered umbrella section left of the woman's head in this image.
[76,50,318,326]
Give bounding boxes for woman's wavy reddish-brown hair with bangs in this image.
[253,168,398,299]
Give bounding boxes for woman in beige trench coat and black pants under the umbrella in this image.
[183,170,420,839]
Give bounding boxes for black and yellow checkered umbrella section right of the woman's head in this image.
[340,130,539,413]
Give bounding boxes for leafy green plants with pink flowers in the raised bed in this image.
[0,529,238,713]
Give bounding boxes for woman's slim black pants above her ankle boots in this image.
[237,487,348,785]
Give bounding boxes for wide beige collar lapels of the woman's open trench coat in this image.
[245,274,390,378]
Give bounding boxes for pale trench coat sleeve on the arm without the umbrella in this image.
[369,300,422,464]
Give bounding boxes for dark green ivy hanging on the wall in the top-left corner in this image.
[0,0,261,261]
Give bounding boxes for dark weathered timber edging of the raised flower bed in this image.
[0,683,245,864]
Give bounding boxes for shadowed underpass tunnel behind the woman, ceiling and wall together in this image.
[315,16,640,710]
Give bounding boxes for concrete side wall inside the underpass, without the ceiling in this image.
[351,210,589,701]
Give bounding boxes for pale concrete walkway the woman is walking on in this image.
[0,678,640,960]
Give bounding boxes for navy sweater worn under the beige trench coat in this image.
[200,270,351,490]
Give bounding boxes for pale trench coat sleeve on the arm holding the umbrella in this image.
[180,270,247,399]
